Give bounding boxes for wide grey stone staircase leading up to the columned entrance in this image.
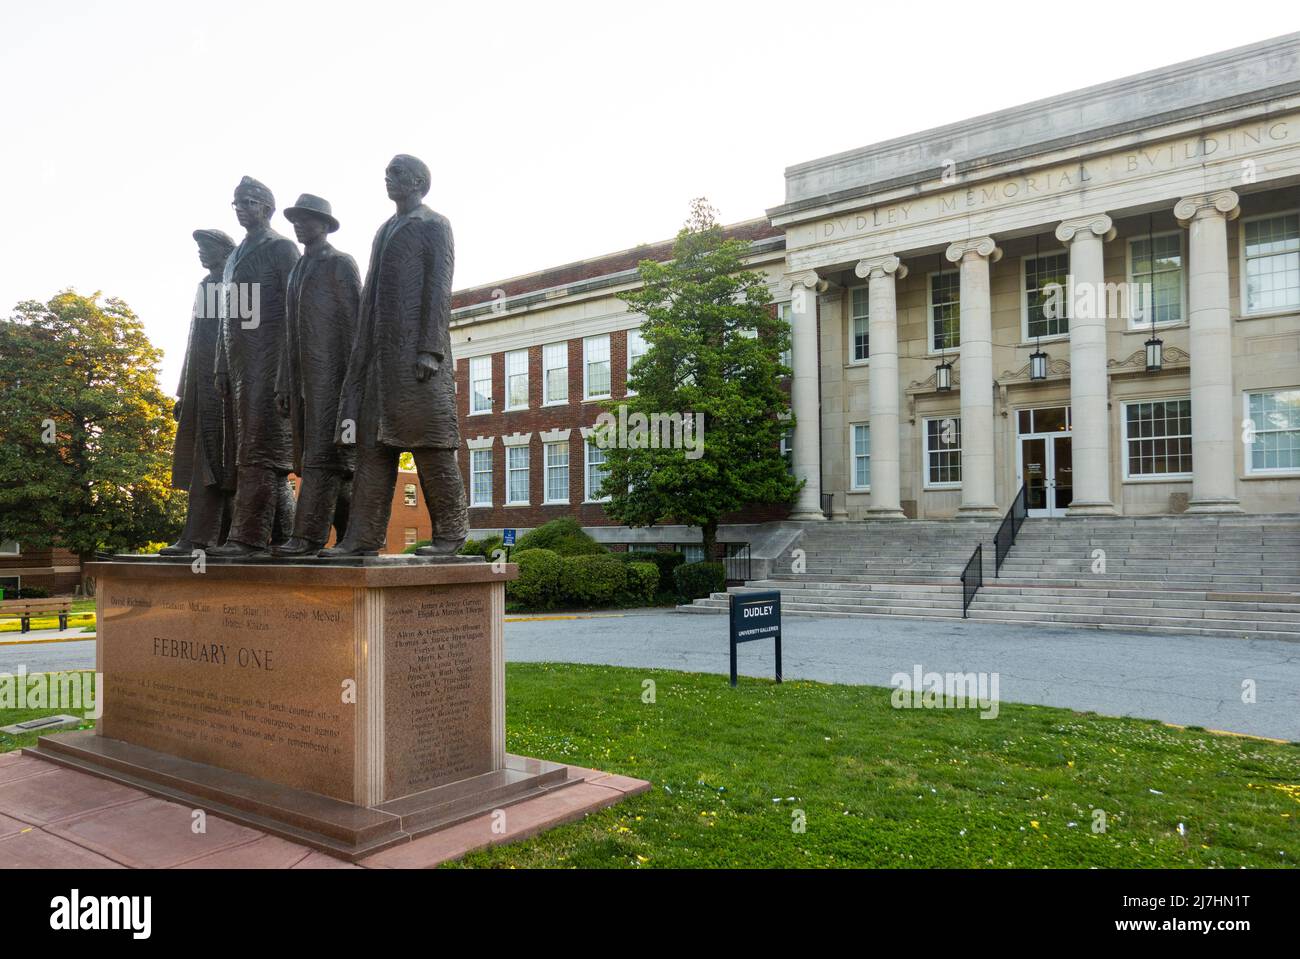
[679,515,1300,642]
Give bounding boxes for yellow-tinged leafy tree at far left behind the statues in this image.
[0,290,186,574]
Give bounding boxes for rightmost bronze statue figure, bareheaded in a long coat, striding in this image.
[320,155,469,556]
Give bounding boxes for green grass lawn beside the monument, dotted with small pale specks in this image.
[0,663,1300,868]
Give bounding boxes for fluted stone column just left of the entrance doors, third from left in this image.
[946,237,1002,516]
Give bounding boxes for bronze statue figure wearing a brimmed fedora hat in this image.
[270,194,361,556]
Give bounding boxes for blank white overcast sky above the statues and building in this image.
[0,0,1300,391]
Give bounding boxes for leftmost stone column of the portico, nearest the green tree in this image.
[785,270,827,520]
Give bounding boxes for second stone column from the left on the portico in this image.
[850,255,907,520]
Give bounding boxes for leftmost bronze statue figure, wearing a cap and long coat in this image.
[160,230,235,556]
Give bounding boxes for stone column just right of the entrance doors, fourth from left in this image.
[1056,213,1115,516]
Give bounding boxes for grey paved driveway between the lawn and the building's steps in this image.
[0,609,1300,741]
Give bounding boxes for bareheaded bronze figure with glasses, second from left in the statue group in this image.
[208,177,298,557]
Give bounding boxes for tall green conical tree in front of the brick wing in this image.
[598,200,802,556]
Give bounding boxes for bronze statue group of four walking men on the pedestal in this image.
[163,155,468,559]
